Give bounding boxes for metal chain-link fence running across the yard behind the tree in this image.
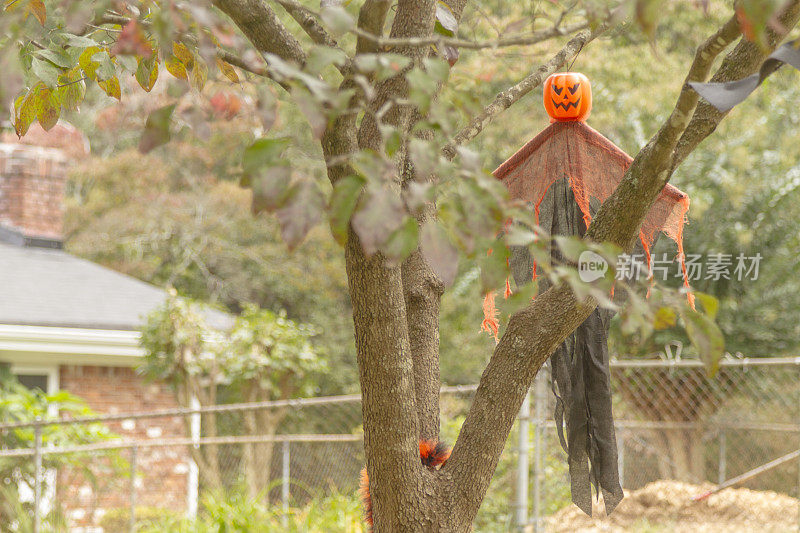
[0,358,800,533]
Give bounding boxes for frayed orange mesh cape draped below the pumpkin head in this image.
[484,122,694,336]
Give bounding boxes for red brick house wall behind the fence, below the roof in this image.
[57,366,189,530]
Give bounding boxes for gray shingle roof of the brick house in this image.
[0,242,233,330]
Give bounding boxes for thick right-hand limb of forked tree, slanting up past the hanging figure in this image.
[444,12,739,516]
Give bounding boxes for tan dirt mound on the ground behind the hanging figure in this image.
[547,481,800,533]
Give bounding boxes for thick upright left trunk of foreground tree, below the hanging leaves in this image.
[345,229,432,531]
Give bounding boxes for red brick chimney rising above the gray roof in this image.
[0,123,88,248]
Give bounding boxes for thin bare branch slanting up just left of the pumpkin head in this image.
[442,25,607,159]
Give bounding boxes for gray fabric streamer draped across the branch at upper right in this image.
[689,39,800,113]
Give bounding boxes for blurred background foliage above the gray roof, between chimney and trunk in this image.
[66,92,357,393]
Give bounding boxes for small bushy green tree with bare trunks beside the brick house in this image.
[139,288,325,498]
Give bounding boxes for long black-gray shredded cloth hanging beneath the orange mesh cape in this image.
[510,180,623,516]
